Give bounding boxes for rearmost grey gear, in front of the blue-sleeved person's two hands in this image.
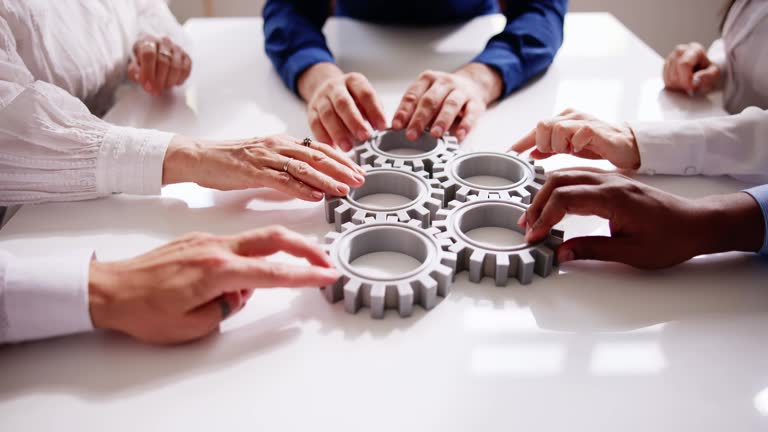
[355,129,459,175]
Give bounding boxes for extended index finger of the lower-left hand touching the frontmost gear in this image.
[231,225,331,267]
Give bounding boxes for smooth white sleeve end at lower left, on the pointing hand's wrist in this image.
[0,250,93,344]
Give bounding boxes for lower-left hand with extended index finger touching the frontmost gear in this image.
[88,226,339,344]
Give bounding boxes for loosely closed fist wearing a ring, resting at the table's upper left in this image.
[128,36,192,96]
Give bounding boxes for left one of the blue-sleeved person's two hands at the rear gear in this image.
[297,63,387,151]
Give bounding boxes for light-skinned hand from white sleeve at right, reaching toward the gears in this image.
[509,109,640,169]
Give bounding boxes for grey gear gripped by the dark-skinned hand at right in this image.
[432,196,563,286]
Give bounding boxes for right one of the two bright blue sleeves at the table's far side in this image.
[474,0,568,97]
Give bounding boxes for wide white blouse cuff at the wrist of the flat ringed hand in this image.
[96,126,174,195]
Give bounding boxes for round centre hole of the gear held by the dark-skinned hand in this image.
[458,204,526,248]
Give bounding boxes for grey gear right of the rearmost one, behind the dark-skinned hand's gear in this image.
[432,152,546,204]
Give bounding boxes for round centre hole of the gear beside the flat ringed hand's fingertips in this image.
[347,171,424,209]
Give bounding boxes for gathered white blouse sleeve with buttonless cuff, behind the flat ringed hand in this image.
[0,17,173,206]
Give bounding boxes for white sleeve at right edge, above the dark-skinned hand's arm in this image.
[630,107,768,183]
